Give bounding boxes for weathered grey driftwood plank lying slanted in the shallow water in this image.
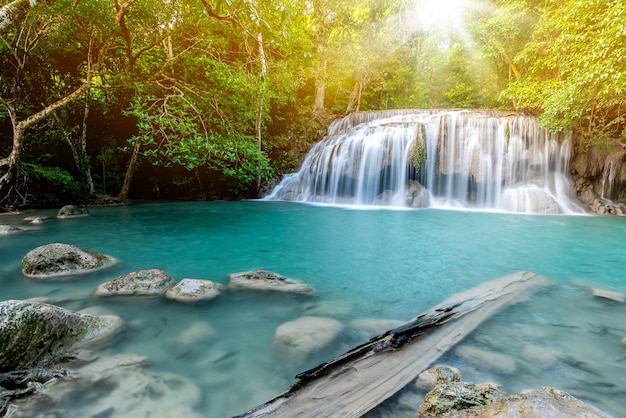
[239,272,548,418]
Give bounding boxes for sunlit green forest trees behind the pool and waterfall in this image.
[0,0,626,209]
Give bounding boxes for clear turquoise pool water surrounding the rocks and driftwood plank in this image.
[0,202,626,417]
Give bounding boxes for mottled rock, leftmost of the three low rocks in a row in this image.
[96,269,176,296]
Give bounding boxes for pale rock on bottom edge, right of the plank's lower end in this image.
[444,387,607,418]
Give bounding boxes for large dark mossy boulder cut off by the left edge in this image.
[0,300,121,372]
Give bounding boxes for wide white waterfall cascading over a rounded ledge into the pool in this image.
[266,110,584,213]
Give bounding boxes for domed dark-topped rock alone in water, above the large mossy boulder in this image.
[22,243,115,279]
